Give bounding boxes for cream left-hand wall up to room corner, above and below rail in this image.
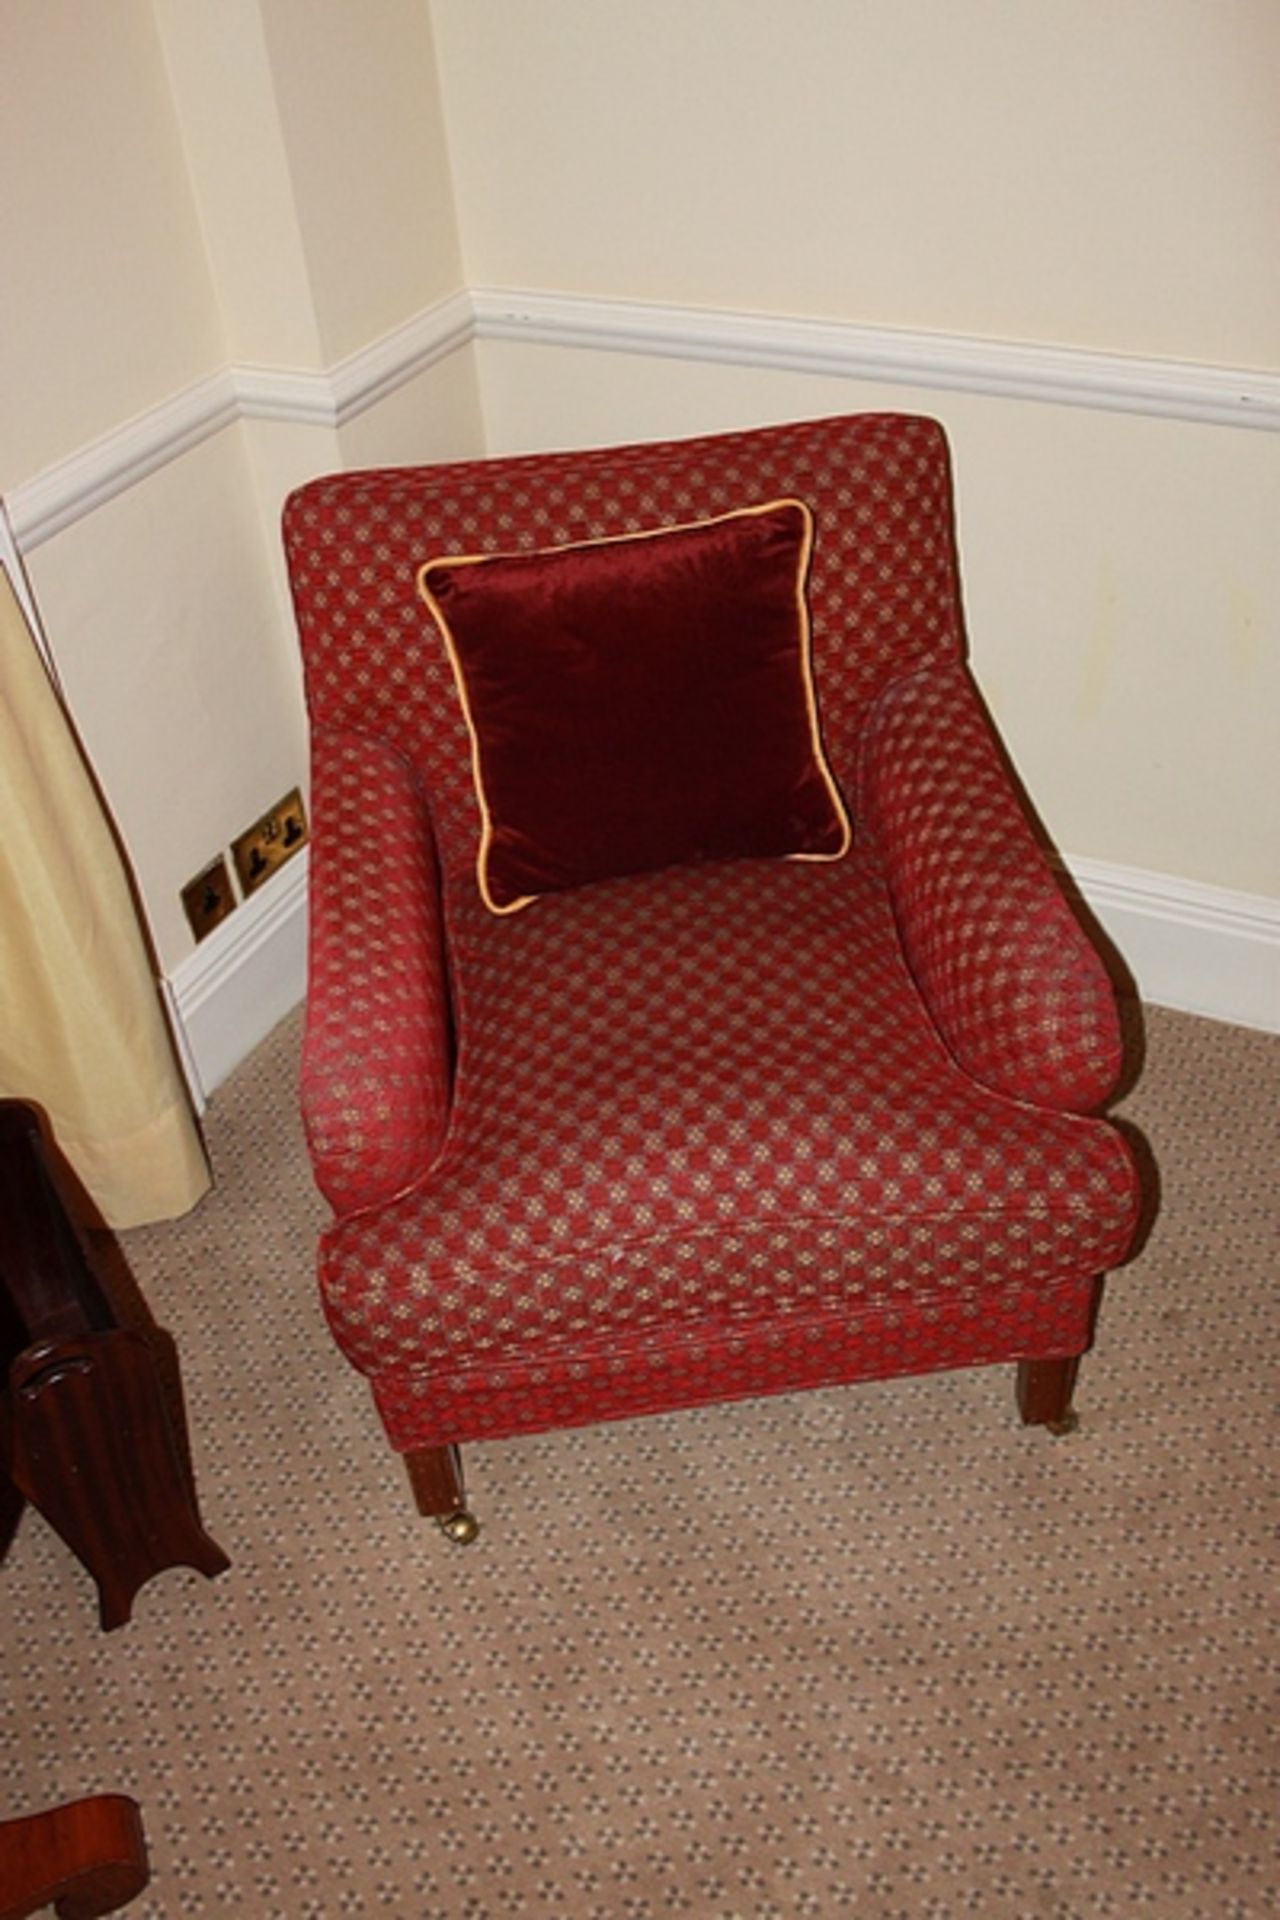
[0,0,480,973]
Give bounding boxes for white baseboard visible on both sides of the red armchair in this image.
[165,849,1280,1110]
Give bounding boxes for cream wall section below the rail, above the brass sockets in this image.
[29,428,305,962]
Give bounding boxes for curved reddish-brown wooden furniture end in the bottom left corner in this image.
[0,1793,150,1920]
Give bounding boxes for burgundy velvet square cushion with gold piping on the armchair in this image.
[418,499,850,914]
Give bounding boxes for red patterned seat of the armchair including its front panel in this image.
[320,847,1136,1446]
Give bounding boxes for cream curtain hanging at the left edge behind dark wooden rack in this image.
[0,566,209,1227]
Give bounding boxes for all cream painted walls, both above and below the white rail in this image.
[0,0,1280,1029]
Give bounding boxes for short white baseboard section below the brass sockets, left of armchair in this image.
[165,847,307,1112]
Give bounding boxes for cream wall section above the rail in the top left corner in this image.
[0,0,225,490]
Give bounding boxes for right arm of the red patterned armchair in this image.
[858,666,1123,1112]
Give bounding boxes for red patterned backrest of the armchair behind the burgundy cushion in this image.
[284,413,961,879]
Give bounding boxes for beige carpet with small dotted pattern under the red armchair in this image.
[0,1012,1280,1920]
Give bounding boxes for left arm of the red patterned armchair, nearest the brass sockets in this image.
[299,732,451,1213]
